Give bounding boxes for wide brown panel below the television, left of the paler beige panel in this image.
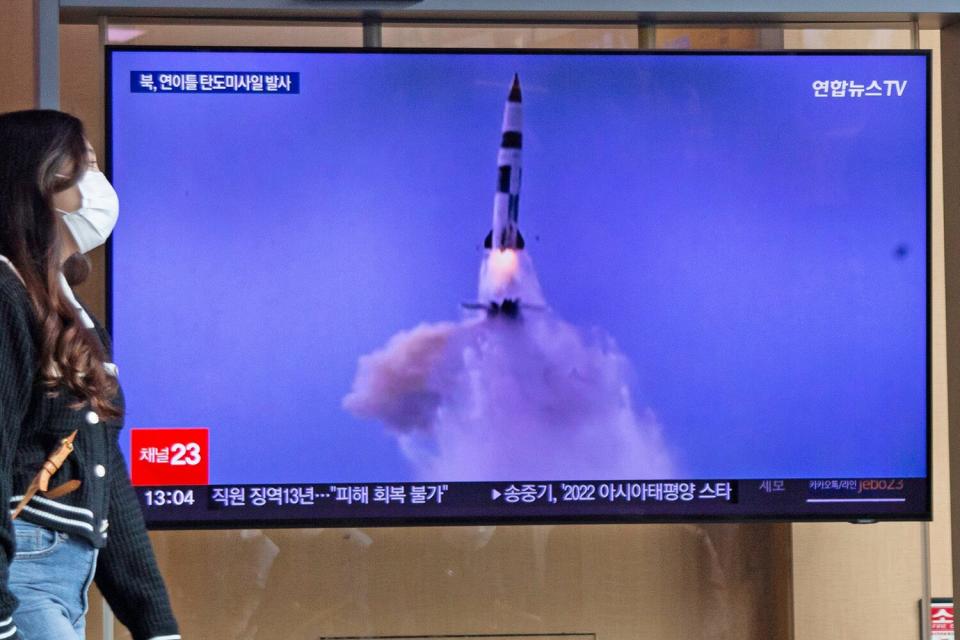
[141,525,789,640]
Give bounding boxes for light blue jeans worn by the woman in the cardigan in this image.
[9,519,97,640]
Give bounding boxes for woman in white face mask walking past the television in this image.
[0,111,180,640]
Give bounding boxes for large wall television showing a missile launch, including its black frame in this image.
[107,47,930,528]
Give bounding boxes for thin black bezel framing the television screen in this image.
[104,45,933,531]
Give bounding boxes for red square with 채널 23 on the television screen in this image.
[130,428,210,486]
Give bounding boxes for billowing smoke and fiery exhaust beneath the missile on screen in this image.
[343,250,676,481]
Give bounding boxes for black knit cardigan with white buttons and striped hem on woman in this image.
[0,263,180,640]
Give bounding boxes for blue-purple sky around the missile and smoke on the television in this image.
[111,51,927,483]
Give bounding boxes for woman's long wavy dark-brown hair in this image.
[0,110,119,417]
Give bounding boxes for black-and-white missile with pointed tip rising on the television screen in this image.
[483,74,524,251]
